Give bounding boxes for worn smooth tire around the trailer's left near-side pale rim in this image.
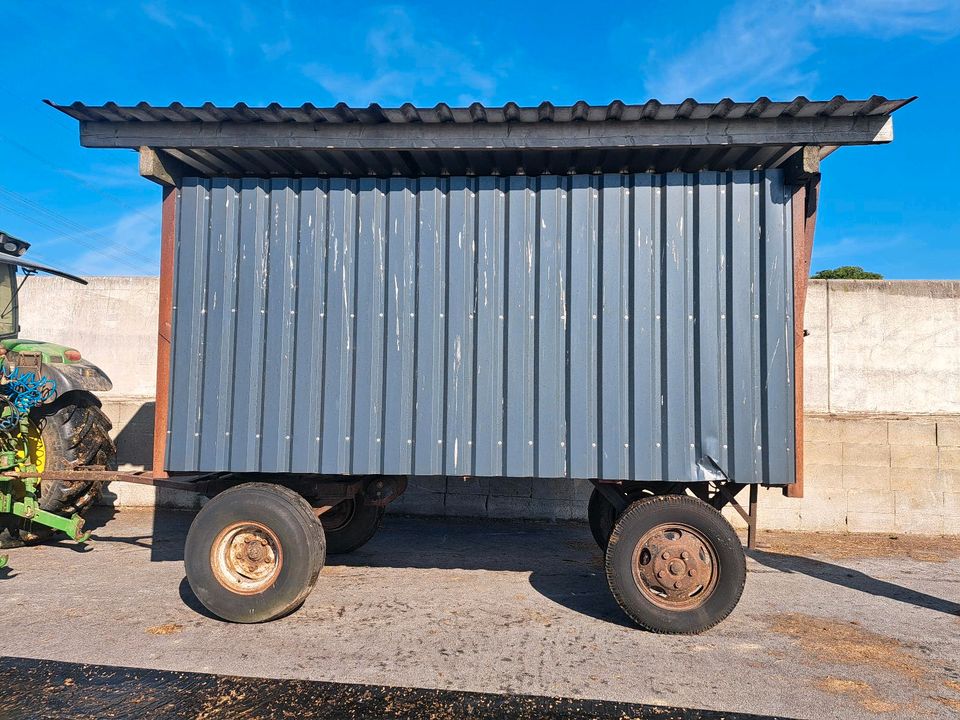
[183,483,326,623]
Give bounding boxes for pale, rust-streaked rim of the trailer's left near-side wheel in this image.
[210,521,283,595]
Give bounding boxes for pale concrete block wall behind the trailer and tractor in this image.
[21,278,960,534]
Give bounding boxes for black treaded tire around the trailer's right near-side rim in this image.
[606,495,747,635]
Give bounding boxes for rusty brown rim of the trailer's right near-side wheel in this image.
[632,523,720,610]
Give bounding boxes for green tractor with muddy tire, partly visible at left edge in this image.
[0,232,116,556]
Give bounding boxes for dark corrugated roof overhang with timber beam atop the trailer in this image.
[50,96,913,183]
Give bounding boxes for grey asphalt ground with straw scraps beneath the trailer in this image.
[0,509,960,720]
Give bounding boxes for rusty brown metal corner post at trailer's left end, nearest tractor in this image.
[153,185,179,478]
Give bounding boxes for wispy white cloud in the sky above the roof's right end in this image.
[645,0,960,102]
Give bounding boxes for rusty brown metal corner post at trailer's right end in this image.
[784,173,820,498]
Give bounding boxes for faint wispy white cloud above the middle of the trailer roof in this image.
[302,7,497,105]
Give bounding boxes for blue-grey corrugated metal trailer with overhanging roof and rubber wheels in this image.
[35,96,910,633]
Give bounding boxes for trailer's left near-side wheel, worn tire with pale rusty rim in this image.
[184,483,326,623]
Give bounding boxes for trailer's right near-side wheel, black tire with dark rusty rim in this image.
[606,495,746,634]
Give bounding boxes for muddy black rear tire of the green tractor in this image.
[0,390,117,547]
